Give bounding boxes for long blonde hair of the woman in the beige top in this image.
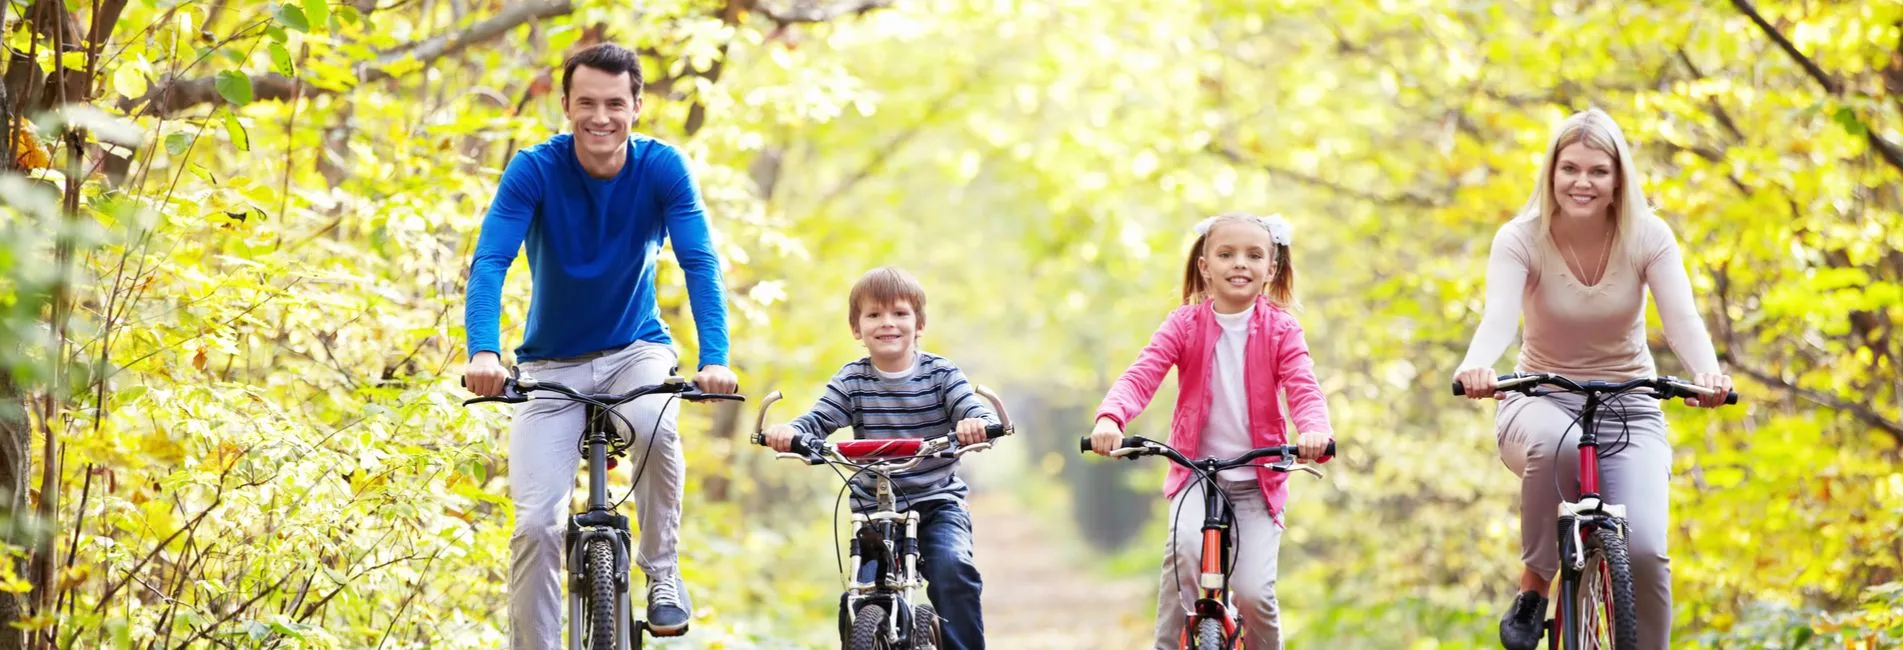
[1520,108,1652,258]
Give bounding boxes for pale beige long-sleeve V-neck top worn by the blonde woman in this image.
[1460,217,1718,380]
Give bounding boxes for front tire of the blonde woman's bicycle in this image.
[1564,526,1638,650]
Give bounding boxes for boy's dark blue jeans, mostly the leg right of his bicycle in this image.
[860,500,984,650]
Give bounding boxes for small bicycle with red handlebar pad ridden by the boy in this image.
[754,386,1014,650]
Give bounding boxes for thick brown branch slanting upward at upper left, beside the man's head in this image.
[132,0,575,116]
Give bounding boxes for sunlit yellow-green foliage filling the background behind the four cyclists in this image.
[0,0,1903,648]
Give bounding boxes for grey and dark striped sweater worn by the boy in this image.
[792,352,997,511]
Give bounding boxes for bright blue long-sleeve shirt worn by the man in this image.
[462,133,727,367]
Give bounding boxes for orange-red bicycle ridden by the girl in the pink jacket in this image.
[1079,435,1334,650]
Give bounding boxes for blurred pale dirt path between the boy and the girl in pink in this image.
[971,492,1155,650]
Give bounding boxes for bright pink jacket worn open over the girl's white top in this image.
[1096,296,1334,525]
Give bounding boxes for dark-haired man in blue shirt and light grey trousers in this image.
[464,44,738,650]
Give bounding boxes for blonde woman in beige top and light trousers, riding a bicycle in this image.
[1454,108,1732,650]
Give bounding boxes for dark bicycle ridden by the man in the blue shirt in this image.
[462,367,746,650]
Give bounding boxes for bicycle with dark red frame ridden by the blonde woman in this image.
[1454,373,1737,650]
